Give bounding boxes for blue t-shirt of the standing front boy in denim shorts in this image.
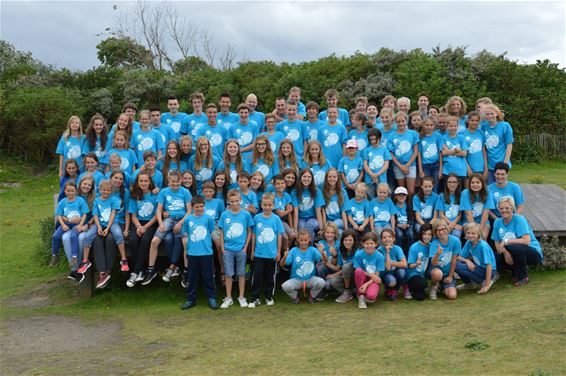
[218,210,254,252]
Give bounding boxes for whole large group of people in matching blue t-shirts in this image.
[50,87,543,309]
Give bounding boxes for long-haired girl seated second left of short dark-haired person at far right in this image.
[435,173,462,239]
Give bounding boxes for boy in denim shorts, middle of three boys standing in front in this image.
[218,189,254,309]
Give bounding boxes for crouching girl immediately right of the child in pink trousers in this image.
[377,228,407,301]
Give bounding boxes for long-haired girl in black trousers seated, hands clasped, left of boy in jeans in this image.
[126,171,157,287]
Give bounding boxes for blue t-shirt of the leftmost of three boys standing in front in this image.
[183,214,214,256]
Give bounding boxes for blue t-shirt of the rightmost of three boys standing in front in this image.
[254,213,285,260]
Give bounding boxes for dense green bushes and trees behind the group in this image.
[0,41,566,163]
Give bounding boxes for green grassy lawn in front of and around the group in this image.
[0,161,566,375]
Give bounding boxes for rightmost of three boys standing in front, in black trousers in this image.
[248,192,285,308]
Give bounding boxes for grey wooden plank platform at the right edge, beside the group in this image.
[521,184,566,238]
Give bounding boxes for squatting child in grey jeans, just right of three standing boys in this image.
[280,229,327,304]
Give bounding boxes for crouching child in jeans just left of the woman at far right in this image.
[456,222,496,294]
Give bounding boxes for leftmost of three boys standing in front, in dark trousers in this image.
[181,196,218,310]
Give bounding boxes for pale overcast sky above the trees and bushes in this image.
[0,0,566,70]
